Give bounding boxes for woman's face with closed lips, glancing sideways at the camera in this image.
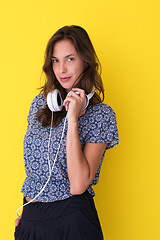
[52,40,85,92]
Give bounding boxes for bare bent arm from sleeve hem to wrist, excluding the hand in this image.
[67,120,107,195]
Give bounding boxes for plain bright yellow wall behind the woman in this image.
[0,0,160,240]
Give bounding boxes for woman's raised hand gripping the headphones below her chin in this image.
[63,88,86,122]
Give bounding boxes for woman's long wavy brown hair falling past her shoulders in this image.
[37,25,104,127]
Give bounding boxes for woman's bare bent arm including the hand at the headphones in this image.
[64,89,107,195]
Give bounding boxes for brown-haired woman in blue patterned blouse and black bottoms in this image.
[15,25,118,240]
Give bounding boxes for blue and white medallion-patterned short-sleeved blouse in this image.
[21,94,119,202]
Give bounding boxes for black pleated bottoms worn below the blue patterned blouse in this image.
[14,191,103,240]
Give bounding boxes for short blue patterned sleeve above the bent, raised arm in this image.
[86,103,119,150]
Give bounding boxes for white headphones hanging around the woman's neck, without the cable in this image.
[47,88,95,112]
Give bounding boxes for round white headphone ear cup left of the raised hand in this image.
[47,89,63,112]
